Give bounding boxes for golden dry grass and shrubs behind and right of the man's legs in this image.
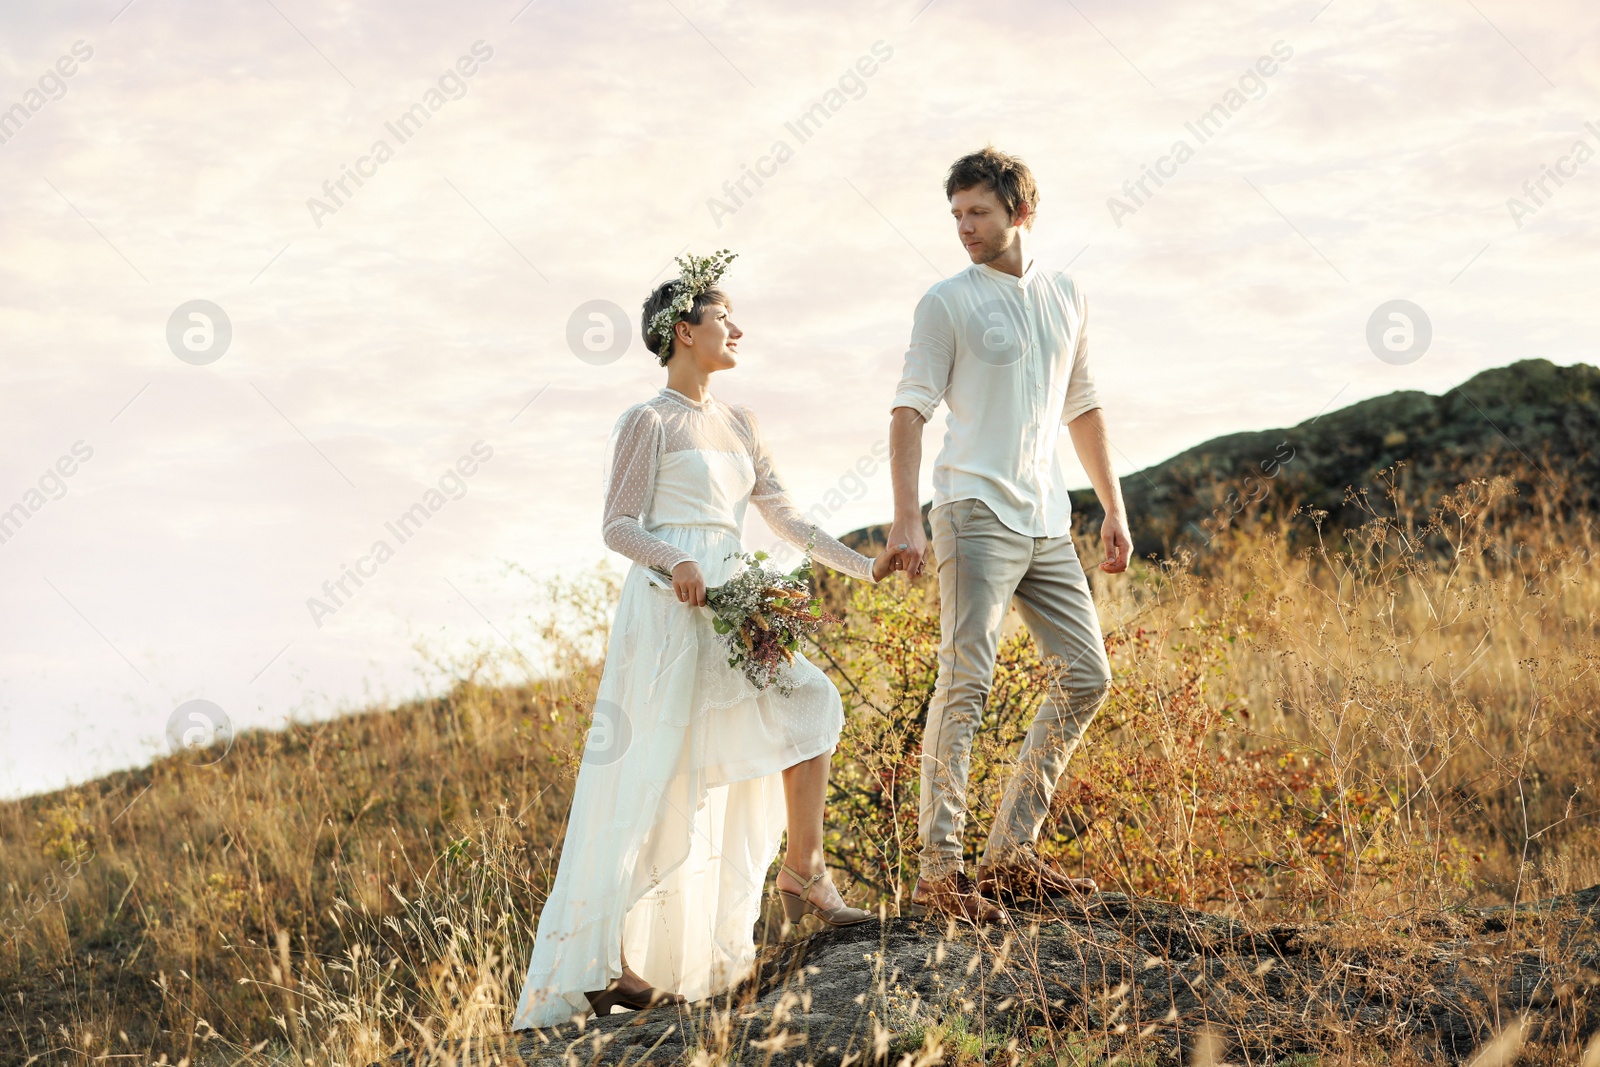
[824,480,1600,918]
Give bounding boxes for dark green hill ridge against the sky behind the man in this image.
[842,358,1600,557]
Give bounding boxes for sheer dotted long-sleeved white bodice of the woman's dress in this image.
[603,389,872,584]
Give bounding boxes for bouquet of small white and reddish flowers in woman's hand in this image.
[659,552,838,696]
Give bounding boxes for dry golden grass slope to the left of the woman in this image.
[0,577,614,1065]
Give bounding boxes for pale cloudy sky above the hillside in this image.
[0,0,1600,797]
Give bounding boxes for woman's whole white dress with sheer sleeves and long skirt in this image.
[512,389,872,1030]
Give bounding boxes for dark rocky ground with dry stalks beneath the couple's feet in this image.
[377,886,1600,1067]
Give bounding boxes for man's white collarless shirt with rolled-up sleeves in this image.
[890,261,1099,537]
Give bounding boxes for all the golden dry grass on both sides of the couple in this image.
[0,480,1600,1065]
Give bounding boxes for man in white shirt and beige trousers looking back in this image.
[888,147,1133,921]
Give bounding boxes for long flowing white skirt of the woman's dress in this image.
[512,526,843,1030]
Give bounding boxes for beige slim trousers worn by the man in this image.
[917,499,1110,880]
